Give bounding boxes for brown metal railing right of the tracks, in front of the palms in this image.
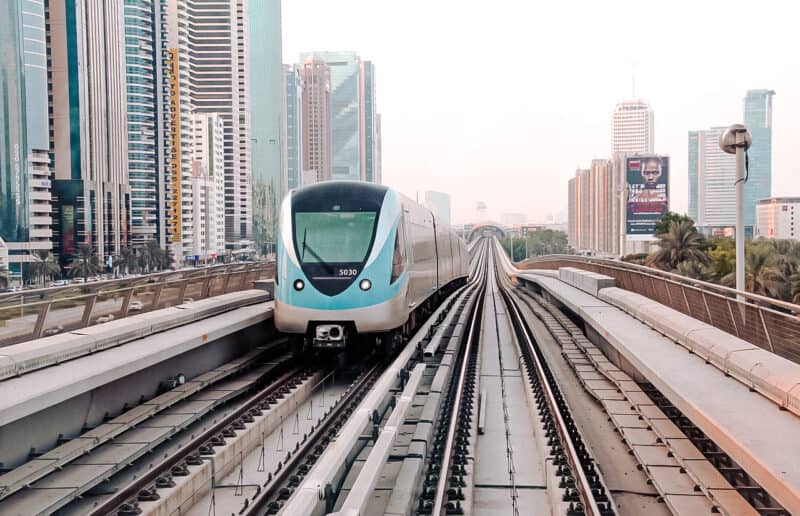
[517,255,800,363]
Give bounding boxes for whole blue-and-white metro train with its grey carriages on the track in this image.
[274,181,469,348]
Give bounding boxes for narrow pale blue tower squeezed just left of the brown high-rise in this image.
[284,65,303,190]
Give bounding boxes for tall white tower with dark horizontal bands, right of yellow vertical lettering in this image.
[187,0,252,249]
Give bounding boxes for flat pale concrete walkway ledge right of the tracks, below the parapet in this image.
[517,266,800,513]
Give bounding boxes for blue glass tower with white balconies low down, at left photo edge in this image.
[0,0,52,277]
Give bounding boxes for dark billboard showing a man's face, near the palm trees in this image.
[625,156,669,240]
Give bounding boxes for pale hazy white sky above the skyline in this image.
[283,0,800,222]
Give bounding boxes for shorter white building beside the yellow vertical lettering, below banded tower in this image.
[192,113,230,262]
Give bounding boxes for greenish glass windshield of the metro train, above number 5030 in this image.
[294,211,378,264]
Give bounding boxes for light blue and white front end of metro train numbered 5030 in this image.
[275,181,408,348]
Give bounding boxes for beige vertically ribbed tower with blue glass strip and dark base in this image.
[48,0,131,261]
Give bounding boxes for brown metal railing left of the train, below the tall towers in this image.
[0,262,275,347]
